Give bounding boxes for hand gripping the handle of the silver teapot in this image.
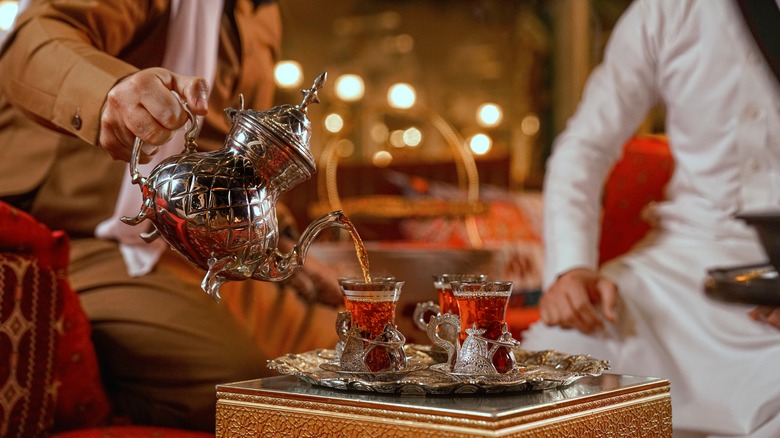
[98,67,209,163]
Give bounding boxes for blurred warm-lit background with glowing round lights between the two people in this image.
[0,0,644,337]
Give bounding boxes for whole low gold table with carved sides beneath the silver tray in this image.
[216,374,672,438]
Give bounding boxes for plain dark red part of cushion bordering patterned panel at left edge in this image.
[0,202,110,436]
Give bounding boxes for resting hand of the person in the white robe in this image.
[539,268,618,333]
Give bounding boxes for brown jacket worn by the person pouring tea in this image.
[0,0,281,237]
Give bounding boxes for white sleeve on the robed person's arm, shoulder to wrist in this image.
[544,0,664,288]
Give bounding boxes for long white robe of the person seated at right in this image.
[523,0,780,437]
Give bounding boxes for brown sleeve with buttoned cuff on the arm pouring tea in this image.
[0,0,168,144]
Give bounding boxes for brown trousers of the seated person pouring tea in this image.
[70,239,337,431]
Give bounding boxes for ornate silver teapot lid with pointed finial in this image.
[232,72,327,171]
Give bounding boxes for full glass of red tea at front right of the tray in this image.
[450,281,517,373]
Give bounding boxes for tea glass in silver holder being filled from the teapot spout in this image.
[337,280,406,372]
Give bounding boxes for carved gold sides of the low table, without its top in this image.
[217,374,672,437]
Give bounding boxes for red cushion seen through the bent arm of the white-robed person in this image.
[599,136,674,263]
